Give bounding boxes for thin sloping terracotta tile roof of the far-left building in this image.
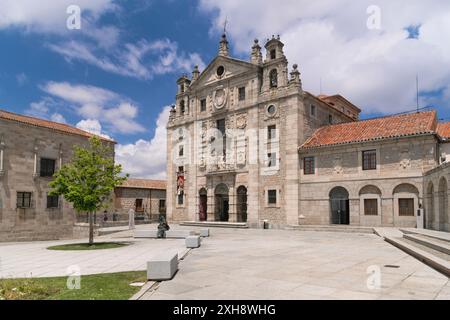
[0,109,115,142]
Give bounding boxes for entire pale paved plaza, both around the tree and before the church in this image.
[0,226,450,300]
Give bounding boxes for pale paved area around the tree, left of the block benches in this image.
[0,231,186,278]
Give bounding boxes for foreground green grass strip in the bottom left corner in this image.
[0,271,147,300]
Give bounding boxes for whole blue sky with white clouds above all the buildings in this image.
[0,0,450,178]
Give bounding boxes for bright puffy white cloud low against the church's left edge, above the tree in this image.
[116,106,170,179]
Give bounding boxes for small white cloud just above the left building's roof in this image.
[38,82,145,134]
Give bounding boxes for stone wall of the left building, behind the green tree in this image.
[0,119,114,241]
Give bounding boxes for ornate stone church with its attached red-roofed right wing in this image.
[167,35,450,231]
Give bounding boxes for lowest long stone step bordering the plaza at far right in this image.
[384,237,450,277]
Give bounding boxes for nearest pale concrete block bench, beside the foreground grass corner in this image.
[147,252,178,281]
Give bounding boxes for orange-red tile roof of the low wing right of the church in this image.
[300,111,437,149]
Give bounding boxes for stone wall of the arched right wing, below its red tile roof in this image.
[300,135,437,227]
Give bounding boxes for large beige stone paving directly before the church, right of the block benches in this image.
[142,229,450,300]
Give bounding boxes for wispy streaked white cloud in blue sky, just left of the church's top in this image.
[48,39,204,79]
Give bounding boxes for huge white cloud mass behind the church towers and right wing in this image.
[200,0,450,113]
